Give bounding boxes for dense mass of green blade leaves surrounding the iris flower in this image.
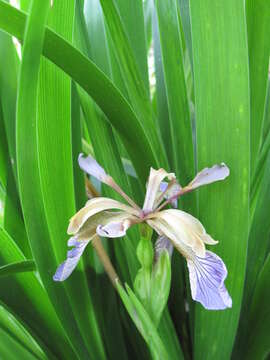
[0,0,270,360]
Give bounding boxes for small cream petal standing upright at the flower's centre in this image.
[143,168,175,214]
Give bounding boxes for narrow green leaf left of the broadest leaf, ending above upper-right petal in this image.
[156,0,194,193]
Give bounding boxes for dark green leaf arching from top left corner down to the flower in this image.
[0,0,158,183]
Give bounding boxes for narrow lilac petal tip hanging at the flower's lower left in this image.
[53,236,90,281]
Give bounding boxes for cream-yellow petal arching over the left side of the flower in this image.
[67,197,139,234]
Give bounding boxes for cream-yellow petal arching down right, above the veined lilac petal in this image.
[146,209,210,257]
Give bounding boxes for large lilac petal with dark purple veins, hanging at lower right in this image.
[187,251,232,310]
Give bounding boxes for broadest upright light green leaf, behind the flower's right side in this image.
[190,0,250,359]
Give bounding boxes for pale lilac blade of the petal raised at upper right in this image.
[186,163,230,190]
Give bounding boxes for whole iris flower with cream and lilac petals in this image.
[54,154,232,310]
